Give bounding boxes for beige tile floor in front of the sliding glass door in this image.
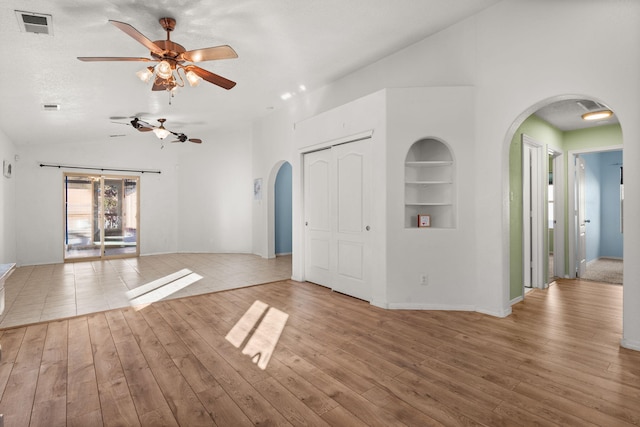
[0,254,291,328]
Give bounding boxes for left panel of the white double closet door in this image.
[304,149,332,287]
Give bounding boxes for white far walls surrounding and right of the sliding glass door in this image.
[15,123,252,265]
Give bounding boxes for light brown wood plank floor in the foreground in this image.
[0,280,640,427]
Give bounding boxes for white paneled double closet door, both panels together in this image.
[304,140,372,301]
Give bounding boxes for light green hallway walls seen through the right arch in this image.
[509,120,622,300]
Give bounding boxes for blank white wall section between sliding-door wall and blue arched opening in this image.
[177,127,253,253]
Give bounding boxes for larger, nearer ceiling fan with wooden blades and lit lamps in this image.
[78,18,238,91]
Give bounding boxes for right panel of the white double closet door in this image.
[331,140,372,301]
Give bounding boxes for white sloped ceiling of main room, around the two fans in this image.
[0,0,499,146]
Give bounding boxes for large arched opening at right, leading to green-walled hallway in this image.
[508,96,623,304]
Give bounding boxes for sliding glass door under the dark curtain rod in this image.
[64,173,140,261]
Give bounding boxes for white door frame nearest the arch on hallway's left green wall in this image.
[522,134,546,295]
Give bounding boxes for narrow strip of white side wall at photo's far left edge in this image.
[0,131,16,264]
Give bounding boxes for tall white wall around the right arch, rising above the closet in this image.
[253,0,640,349]
